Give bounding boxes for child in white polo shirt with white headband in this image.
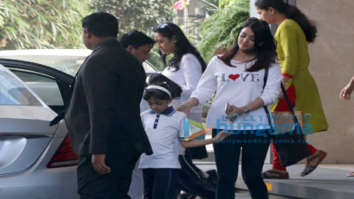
[139,78,227,199]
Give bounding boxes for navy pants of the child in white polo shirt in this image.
[143,169,180,199]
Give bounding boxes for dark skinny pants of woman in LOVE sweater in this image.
[213,129,270,199]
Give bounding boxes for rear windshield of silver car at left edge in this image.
[0,65,41,106]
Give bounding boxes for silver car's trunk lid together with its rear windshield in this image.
[0,65,66,177]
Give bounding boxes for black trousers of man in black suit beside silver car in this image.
[77,153,140,199]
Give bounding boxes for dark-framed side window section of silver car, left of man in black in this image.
[0,59,74,114]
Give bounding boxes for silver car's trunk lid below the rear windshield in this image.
[0,106,57,175]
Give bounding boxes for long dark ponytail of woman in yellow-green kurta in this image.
[255,0,317,43]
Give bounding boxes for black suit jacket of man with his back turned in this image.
[65,39,152,159]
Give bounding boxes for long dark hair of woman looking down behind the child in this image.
[154,23,206,71]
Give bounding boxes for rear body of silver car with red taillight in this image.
[0,64,78,199]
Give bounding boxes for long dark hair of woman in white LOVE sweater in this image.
[219,18,277,72]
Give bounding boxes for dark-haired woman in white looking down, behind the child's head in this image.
[154,23,206,122]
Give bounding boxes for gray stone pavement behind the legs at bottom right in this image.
[196,162,354,199]
